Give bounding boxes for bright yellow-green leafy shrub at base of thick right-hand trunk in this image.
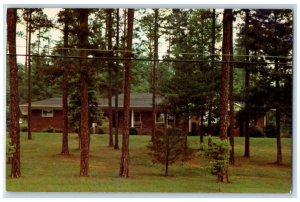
[200,136,231,176]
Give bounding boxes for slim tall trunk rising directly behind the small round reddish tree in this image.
[151,9,158,140]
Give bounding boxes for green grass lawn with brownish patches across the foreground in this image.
[6,133,292,193]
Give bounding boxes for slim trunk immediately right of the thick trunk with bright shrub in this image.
[229,15,234,165]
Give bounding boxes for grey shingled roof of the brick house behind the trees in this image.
[20,93,163,115]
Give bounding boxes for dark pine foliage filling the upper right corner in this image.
[239,9,293,132]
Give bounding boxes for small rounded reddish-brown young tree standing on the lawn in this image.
[148,128,187,176]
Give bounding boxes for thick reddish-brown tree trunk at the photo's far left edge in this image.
[7,8,21,178]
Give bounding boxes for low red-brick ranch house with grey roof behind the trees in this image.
[20,93,265,136]
